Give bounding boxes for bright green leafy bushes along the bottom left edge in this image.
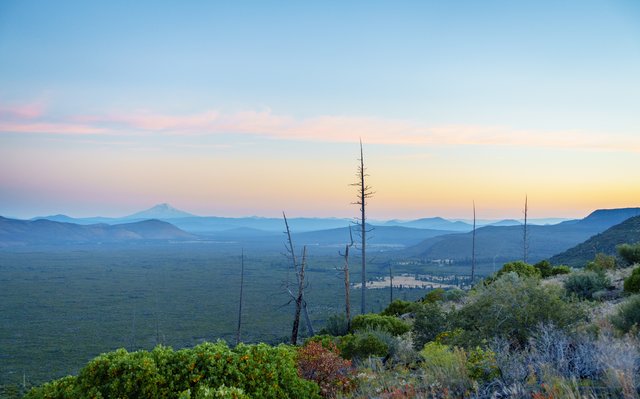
[27,342,318,399]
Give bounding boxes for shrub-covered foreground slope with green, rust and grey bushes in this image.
[13,245,640,399]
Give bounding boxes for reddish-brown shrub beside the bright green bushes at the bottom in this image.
[298,342,353,398]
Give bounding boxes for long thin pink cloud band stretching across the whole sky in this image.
[0,101,640,152]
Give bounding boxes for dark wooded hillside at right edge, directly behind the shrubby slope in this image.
[549,216,640,267]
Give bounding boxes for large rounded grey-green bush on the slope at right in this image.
[451,273,583,347]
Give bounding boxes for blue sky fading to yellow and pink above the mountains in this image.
[0,0,640,219]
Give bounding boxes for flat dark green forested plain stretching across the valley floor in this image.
[0,244,480,390]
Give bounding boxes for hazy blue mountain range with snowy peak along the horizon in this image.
[5,204,640,262]
